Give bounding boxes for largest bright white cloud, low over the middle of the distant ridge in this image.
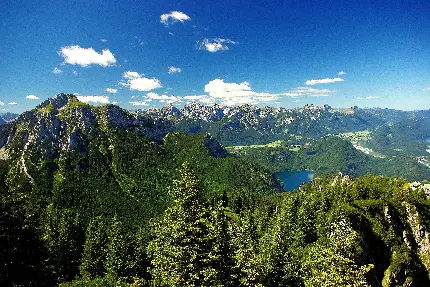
[205,79,279,106]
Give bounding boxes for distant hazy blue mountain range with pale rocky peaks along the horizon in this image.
[136,102,430,145]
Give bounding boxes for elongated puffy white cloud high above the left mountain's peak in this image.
[58,46,116,67]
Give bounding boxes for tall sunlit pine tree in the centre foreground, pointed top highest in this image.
[148,163,228,286]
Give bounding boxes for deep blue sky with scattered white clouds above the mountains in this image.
[0,0,430,112]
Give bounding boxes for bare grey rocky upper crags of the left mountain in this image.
[0,94,227,165]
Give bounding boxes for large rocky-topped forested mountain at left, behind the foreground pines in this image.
[0,94,279,286]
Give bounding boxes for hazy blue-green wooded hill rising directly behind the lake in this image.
[234,136,430,180]
